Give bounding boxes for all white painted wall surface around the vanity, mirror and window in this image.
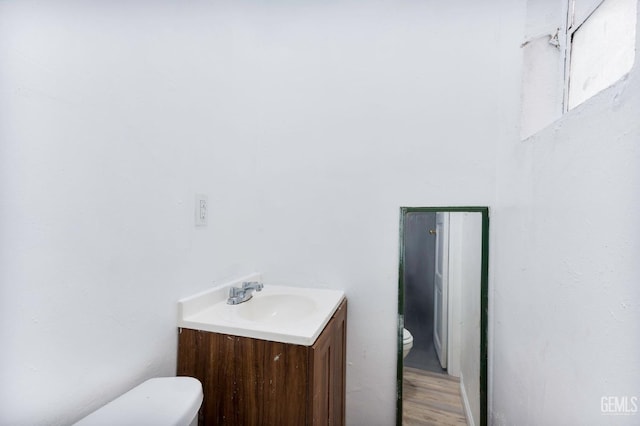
[10,0,640,425]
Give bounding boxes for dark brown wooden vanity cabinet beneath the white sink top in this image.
[178,300,347,426]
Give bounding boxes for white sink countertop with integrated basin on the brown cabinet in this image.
[178,274,344,346]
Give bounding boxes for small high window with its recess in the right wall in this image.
[521,0,637,138]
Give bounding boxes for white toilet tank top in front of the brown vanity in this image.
[76,377,203,426]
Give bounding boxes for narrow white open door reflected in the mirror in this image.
[433,212,449,368]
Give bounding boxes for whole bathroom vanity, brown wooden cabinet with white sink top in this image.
[177,278,347,426]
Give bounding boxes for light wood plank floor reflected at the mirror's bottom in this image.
[402,367,467,426]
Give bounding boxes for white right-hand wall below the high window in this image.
[490,0,640,425]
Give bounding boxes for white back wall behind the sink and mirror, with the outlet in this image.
[0,0,510,425]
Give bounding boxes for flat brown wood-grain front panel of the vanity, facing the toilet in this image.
[178,329,309,426]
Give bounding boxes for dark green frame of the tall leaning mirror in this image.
[396,207,489,426]
